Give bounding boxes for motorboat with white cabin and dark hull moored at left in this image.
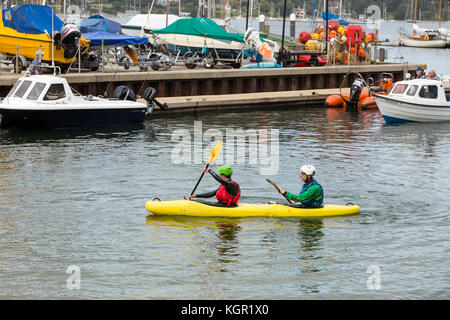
[0,75,162,128]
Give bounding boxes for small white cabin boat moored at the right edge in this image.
[374,79,450,124]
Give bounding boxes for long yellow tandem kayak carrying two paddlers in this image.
[145,200,360,218]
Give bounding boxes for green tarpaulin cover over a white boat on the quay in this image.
[152,18,244,42]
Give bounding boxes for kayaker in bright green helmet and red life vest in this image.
[188,165,241,206]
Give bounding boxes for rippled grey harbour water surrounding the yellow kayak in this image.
[0,108,450,299]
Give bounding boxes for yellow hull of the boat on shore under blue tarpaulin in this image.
[0,14,89,64]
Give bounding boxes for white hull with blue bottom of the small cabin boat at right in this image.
[375,95,450,123]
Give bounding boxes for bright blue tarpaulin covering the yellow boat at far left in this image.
[2,4,64,34]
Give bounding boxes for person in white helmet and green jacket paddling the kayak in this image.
[279,165,323,208]
